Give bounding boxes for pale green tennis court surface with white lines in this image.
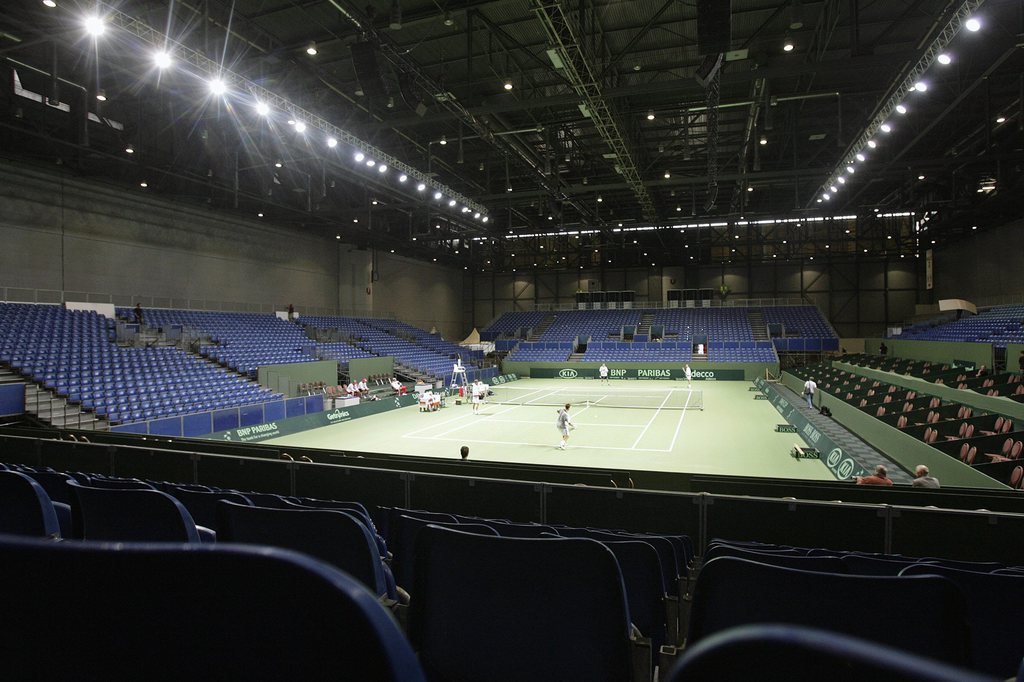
[264,379,835,480]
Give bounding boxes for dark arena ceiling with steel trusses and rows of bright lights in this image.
[0,0,1024,271]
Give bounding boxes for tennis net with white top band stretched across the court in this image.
[487,386,703,410]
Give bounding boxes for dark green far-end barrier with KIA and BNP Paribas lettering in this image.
[502,360,778,381]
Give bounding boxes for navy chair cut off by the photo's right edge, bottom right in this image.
[900,563,1024,678]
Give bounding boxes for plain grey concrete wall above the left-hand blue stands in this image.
[0,163,471,340]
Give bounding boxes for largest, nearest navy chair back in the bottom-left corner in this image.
[0,538,425,682]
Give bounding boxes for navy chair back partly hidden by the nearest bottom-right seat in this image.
[689,557,970,665]
